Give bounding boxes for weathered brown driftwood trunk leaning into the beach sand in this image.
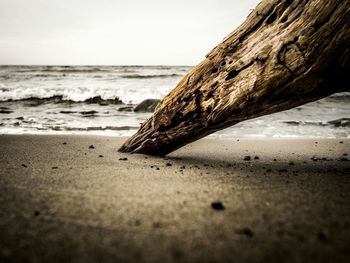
[119,0,350,155]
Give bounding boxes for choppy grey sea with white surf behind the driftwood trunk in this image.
[0,66,350,138]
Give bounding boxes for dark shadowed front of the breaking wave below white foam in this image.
[2,95,123,106]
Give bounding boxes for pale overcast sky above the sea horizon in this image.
[0,0,260,65]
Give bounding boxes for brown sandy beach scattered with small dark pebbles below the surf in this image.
[0,135,350,263]
